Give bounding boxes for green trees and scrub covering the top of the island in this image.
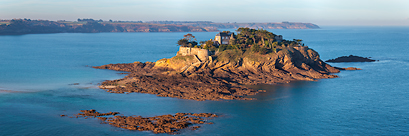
[177,28,304,60]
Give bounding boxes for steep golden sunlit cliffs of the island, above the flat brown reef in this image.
[155,47,339,85]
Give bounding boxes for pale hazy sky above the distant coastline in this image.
[0,0,409,26]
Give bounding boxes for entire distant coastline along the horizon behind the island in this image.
[0,19,319,35]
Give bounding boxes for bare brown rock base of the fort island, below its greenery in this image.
[94,47,339,101]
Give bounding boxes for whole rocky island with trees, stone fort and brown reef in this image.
[94,28,340,101]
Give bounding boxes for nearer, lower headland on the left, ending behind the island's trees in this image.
[0,19,218,35]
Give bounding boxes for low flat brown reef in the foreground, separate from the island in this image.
[71,110,218,134]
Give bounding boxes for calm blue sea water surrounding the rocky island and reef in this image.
[0,26,409,136]
